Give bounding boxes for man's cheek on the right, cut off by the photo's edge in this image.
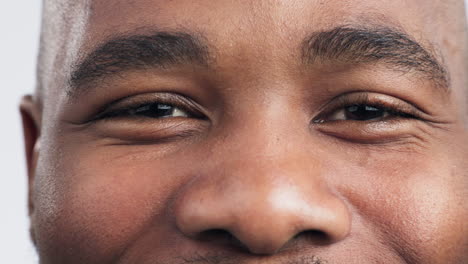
[343,150,468,263]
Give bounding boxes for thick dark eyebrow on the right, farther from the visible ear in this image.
[302,26,450,90]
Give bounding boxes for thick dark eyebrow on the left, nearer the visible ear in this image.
[69,32,208,94]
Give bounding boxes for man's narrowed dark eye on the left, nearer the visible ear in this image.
[86,93,209,144]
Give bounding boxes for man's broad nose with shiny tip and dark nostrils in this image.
[173,154,351,255]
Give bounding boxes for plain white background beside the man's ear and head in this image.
[0,0,468,264]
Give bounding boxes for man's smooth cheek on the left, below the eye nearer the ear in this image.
[34,143,185,263]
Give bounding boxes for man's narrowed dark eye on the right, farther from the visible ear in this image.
[313,92,426,143]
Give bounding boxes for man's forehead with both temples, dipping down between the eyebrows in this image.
[44,0,465,111]
